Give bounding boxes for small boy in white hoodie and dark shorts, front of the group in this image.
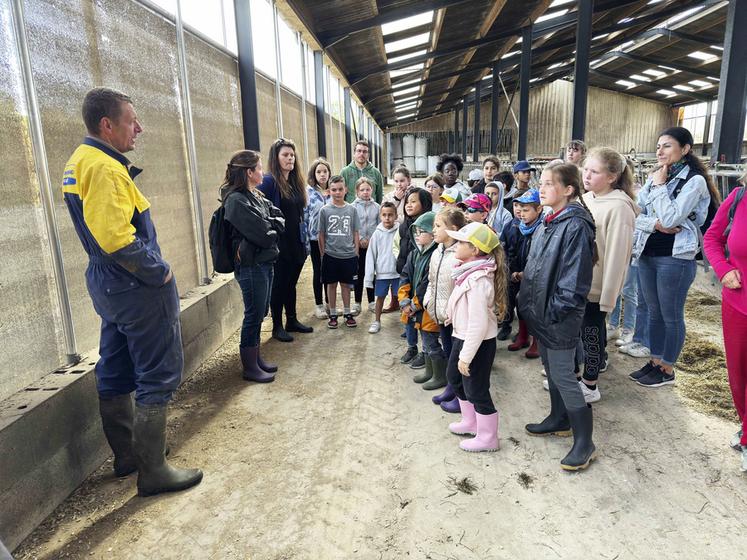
[363,202,399,334]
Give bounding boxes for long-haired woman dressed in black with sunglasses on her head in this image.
[259,138,314,342]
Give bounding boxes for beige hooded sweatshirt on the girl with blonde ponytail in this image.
[584,190,639,313]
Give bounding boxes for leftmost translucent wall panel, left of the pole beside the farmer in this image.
[0,2,64,400]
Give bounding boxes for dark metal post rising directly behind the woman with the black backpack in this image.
[233,0,260,151]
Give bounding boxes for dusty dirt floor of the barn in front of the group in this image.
[16,264,747,560]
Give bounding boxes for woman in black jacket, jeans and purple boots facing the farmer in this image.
[221,150,285,383]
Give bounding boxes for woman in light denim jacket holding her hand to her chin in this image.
[630,126,720,387]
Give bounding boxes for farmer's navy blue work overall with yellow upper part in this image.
[62,137,184,404]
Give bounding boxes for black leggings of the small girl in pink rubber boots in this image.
[446,337,495,414]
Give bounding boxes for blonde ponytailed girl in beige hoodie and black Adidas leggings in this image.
[579,148,638,403]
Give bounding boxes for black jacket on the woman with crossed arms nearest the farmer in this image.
[222,190,285,268]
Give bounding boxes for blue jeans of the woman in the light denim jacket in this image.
[638,256,696,366]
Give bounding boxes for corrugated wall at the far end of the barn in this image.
[390,80,677,157]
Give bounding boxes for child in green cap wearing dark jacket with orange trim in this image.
[398,212,445,383]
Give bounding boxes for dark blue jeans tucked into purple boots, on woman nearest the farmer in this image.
[234,263,273,348]
